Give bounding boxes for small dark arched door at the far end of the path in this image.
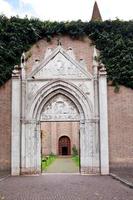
[58,136,71,156]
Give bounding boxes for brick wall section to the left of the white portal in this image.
[0,81,11,170]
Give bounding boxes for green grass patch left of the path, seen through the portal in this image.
[41,155,56,171]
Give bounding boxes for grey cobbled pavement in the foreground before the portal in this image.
[0,174,133,200]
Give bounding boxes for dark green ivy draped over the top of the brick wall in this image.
[0,15,133,88]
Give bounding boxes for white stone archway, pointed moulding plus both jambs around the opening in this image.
[18,79,99,173]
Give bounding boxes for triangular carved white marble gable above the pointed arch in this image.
[29,46,92,79]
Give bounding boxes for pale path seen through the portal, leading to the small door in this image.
[46,157,79,173]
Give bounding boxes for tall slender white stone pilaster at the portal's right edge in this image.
[99,66,109,175]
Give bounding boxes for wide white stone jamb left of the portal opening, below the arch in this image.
[21,120,41,174]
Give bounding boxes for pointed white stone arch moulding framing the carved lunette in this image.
[28,79,93,121]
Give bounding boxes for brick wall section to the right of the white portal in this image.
[108,86,133,167]
